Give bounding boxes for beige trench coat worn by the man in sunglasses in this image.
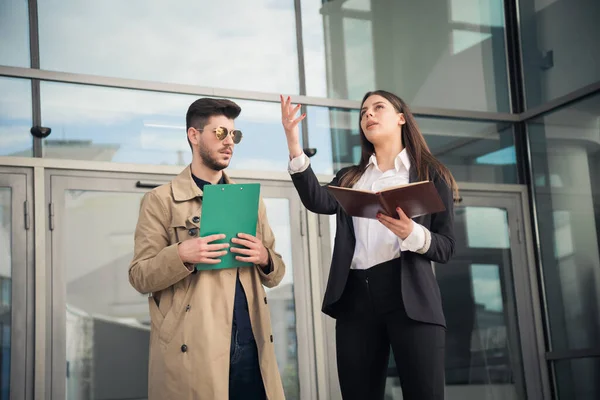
[129,166,285,400]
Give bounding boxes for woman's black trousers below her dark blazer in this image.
[336,259,446,400]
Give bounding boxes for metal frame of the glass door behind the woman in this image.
[309,183,550,400]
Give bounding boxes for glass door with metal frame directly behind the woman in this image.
[319,186,545,400]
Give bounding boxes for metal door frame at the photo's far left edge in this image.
[0,167,34,399]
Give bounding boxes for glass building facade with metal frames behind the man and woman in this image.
[0,0,600,400]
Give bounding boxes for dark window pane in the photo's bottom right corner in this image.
[554,358,600,400]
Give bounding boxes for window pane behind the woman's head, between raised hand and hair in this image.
[306,107,517,183]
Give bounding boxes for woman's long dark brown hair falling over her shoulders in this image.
[340,90,458,199]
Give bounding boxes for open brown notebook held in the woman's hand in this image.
[327,181,446,219]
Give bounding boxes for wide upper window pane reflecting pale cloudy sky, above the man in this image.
[38,0,298,93]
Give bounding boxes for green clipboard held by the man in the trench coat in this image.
[196,183,260,271]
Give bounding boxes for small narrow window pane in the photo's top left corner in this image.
[0,0,30,67]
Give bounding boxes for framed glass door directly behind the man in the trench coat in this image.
[47,171,314,400]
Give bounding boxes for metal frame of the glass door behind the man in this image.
[45,169,317,399]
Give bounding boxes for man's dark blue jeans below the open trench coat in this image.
[229,324,267,400]
